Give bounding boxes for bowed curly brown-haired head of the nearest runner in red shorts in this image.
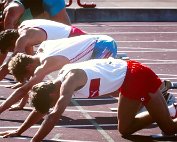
[28,82,57,114]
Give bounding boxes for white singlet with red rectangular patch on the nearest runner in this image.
[58,57,127,98]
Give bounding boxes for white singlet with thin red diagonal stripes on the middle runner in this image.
[37,35,97,63]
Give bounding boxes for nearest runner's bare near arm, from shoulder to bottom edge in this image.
[31,69,86,142]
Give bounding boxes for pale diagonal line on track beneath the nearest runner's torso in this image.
[71,99,114,142]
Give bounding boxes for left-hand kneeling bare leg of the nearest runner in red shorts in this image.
[118,94,153,135]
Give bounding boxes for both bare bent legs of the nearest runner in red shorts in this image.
[118,90,177,135]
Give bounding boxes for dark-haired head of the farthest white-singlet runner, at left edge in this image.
[0,29,19,53]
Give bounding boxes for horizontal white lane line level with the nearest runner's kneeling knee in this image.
[0,124,117,129]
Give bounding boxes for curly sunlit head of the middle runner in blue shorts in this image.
[8,53,34,82]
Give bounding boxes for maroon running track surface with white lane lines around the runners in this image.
[0,22,177,142]
